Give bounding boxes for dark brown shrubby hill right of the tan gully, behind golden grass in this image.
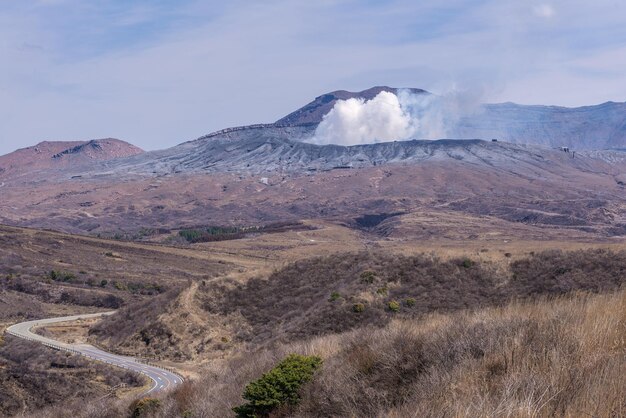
[191,249,626,345]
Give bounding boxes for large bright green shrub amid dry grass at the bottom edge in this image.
[233,354,322,418]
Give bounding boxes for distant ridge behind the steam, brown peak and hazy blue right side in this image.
[275,86,626,150]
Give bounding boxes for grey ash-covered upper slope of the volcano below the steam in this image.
[89,135,626,177]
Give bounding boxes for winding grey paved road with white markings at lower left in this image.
[6,312,182,394]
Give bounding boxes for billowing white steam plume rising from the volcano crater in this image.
[308,90,479,145]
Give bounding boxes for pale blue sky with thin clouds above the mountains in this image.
[0,0,626,154]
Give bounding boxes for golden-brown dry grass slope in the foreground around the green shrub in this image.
[25,290,626,418]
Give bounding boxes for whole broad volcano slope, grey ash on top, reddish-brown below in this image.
[0,136,626,236]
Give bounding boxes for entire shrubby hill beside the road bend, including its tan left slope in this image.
[86,249,626,361]
